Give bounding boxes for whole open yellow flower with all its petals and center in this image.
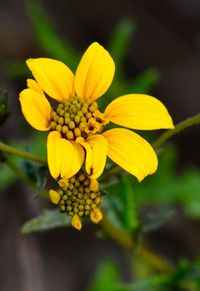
[20,42,173,181]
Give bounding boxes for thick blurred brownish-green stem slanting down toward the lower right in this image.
[101,216,173,273]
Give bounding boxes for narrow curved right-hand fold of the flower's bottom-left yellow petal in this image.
[61,142,85,178]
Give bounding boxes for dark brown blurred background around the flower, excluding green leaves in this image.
[0,0,200,291]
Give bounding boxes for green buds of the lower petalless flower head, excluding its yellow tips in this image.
[58,172,101,217]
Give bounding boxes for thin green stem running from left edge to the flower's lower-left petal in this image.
[0,142,46,164]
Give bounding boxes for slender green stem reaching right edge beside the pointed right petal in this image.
[152,113,200,150]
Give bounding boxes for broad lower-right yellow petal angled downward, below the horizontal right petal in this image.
[103,128,158,181]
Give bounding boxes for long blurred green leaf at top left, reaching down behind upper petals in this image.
[27,0,79,70]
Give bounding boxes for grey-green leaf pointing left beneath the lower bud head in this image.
[21,209,70,234]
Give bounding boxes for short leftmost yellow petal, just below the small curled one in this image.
[19,89,51,131]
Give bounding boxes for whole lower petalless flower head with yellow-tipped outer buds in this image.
[49,171,102,229]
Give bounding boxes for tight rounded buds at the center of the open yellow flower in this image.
[51,96,98,140]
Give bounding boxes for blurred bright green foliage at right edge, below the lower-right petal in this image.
[135,146,200,219]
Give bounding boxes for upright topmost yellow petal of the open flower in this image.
[75,42,115,100]
